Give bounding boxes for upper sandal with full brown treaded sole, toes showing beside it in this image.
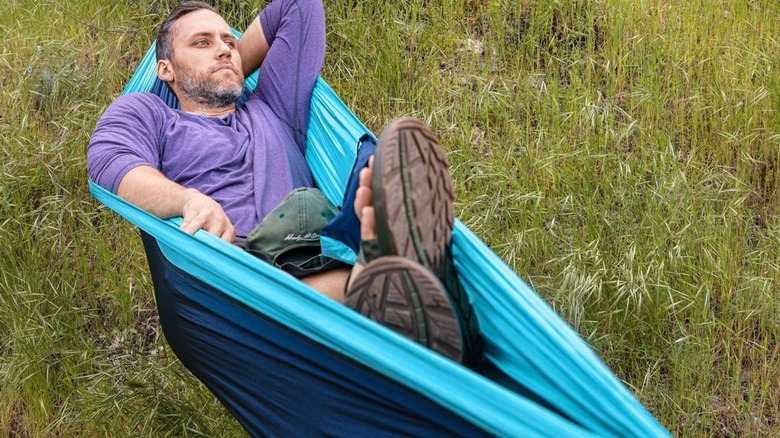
[363,118,482,365]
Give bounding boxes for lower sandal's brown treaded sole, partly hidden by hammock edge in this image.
[344,256,464,362]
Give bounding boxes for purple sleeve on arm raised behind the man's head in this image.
[255,0,325,151]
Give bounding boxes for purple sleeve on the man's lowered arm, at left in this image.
[87,93,165,194]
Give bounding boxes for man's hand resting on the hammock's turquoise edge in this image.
[180,189,236,242]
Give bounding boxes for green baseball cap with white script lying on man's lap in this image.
[246,187,339,266]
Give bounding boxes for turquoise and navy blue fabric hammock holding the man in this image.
[90,38,668,437]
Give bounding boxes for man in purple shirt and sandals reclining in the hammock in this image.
[87,0,475,362]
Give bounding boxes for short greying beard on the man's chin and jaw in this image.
[175,60,244,108]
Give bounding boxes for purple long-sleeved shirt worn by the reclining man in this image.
[87,0,325,236]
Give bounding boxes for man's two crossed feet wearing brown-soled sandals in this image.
[345,118,481,364]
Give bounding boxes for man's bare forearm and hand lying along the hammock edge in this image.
[117,166,236,242]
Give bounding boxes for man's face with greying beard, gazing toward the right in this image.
[170,9,244,108]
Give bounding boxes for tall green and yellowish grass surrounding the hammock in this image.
[0,0,780,437]
